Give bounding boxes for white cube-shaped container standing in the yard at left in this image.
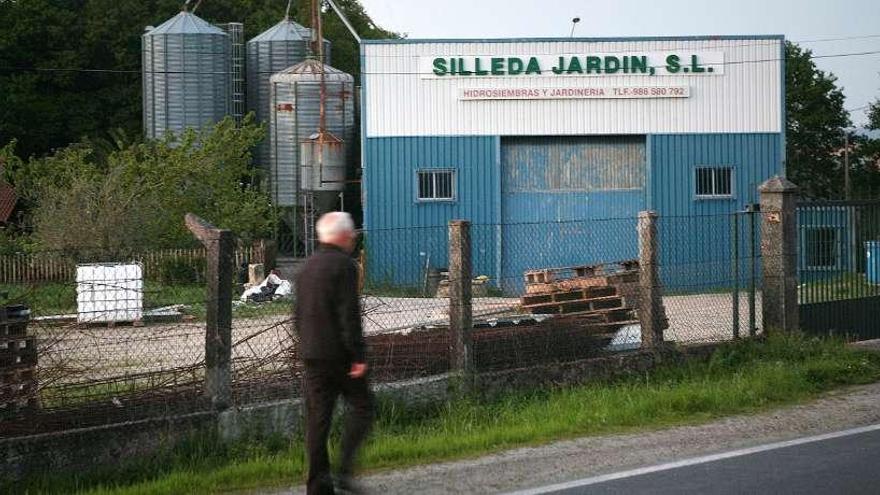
[76,263,144,323]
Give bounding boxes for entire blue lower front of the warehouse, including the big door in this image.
[363,133,782,291]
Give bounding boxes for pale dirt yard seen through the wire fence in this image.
[32,294,761,383]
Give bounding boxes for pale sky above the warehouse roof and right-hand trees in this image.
[361,0,880,126]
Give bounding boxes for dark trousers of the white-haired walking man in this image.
[303,360,373,495]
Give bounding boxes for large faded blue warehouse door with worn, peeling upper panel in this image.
[501,136,646,292]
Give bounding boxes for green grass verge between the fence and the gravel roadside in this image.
[15,336,880,495]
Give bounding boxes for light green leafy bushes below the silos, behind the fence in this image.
[8,116,274,253]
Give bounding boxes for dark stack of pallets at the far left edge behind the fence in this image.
[0,305,37,415]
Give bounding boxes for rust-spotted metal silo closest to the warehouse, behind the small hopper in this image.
[269,59,355,207]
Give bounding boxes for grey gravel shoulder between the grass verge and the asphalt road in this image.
[258,383,880,495]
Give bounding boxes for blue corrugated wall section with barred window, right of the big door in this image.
[648,133,782,292]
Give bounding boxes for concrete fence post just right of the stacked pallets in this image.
[638,211,664,349]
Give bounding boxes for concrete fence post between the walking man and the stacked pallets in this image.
[449,220,473,374]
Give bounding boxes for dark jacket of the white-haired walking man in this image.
[294,244,365,363]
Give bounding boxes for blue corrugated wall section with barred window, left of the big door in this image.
[363,137,500,286]
